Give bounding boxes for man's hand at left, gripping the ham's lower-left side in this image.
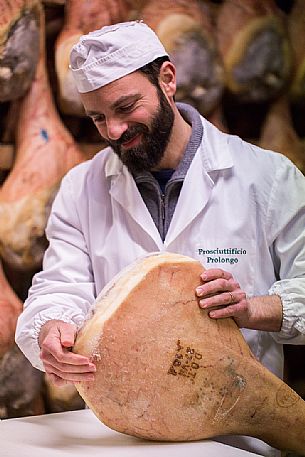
[38,320,96,386]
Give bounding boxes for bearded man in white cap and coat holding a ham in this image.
[16,22,305,456]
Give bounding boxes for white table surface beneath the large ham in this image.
[0,409,257,457]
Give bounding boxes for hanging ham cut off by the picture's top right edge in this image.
[288,0,305,101]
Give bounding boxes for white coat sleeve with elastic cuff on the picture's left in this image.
[16,174,96,370]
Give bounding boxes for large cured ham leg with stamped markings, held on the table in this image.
[74,253,305,453]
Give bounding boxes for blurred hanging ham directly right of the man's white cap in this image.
[139,0,223,115]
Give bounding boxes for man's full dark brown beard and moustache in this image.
[106,88,174,173]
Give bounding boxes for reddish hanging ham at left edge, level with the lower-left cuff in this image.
[0,263,22,358]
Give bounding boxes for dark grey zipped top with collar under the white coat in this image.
[133,103,203,241]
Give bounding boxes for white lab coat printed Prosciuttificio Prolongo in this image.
[16,118,305,455]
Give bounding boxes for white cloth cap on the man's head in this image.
[70,21,168,93]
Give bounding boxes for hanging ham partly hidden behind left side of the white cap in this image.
[55,0,127,116]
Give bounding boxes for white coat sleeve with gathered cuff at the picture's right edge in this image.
[266,157,305,344]
